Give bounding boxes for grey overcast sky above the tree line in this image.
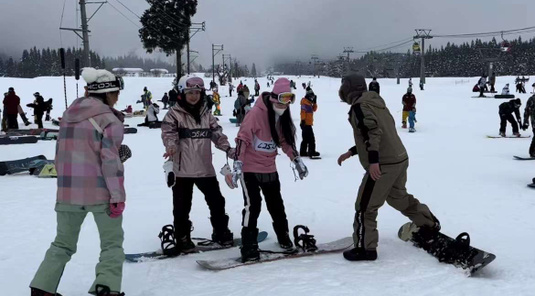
[0,0,535,71]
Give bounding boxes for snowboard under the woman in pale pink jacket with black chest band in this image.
[125,231,268,263]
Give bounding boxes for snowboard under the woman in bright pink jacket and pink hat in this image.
[197,237,353,270]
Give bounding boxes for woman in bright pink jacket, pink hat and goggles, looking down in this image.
[231,78,308,262]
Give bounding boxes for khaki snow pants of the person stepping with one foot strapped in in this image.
[353,159,438,250]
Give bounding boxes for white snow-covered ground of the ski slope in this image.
[0,73,535,296]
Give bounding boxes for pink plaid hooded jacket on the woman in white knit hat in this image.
[56,97,125,205]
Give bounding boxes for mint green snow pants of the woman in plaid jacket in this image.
[30,204,124,295]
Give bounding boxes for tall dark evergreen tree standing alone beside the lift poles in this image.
[139,0,197,77]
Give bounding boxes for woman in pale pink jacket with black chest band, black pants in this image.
[161,76,234,256]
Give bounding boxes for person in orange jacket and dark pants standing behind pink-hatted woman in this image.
[299,87,320,158]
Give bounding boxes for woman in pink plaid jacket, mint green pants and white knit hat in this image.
[30,68,131,296]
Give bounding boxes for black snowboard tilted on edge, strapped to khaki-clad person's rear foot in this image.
[398,222,496,274]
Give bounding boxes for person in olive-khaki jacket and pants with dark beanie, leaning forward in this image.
[338,74,440,261]
